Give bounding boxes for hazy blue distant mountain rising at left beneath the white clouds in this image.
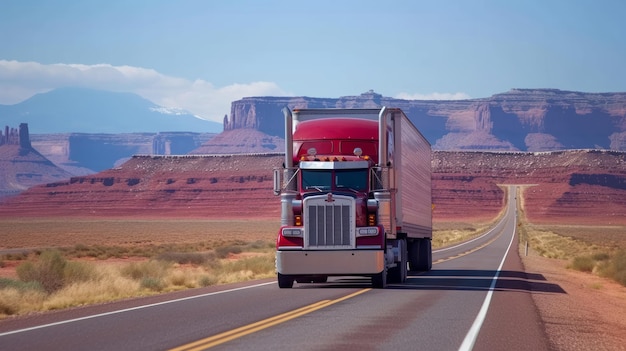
[0,88,222,134]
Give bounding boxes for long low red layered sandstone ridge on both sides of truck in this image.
[0,150,626,225]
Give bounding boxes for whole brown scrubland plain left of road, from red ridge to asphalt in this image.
[0,219,279,318]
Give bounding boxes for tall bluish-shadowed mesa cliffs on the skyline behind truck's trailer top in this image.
[224,89,626,151]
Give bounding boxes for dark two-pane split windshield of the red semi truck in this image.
[302,169,367,191]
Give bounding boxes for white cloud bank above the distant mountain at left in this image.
[0,60,292,123]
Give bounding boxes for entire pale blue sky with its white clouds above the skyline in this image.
[0,0,626,122]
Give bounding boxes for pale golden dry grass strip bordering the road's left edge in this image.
[0,245,275,318]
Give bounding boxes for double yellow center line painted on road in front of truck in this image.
[170,288,372,351]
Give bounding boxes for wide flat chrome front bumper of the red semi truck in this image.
[276,250,385,275]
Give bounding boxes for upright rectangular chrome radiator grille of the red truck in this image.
[305,196,355,249]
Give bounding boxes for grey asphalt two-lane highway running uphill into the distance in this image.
[0,186,565,351]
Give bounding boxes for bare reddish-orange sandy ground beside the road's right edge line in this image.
[520,246,626,351]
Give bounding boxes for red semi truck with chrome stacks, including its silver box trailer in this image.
[274,107,432,288]
